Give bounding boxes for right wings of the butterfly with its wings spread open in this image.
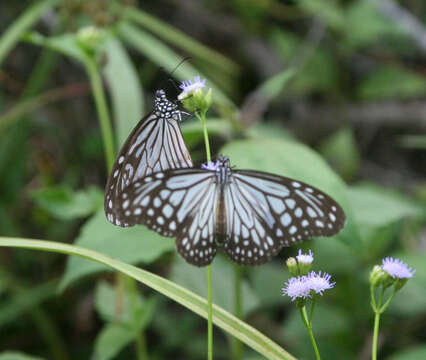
[224,170,345,265]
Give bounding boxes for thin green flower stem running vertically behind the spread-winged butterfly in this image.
[199,111,213,360]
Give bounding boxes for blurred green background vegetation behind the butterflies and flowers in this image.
[0,0,426,360]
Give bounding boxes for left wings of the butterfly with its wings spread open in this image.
[118,169,219,266]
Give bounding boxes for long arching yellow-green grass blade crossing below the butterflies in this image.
[0,236,295,360]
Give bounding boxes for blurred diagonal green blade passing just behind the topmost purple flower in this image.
[118,23,233,107]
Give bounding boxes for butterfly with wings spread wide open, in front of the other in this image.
[117,156,346,266]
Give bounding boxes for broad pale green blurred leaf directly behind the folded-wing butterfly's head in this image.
[103,37,144,147]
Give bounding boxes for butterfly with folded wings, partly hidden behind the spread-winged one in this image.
[104,90,192,227]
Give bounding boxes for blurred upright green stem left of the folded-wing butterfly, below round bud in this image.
[84,57,115,172]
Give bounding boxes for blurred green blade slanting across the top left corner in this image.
[0,0,59,65]
